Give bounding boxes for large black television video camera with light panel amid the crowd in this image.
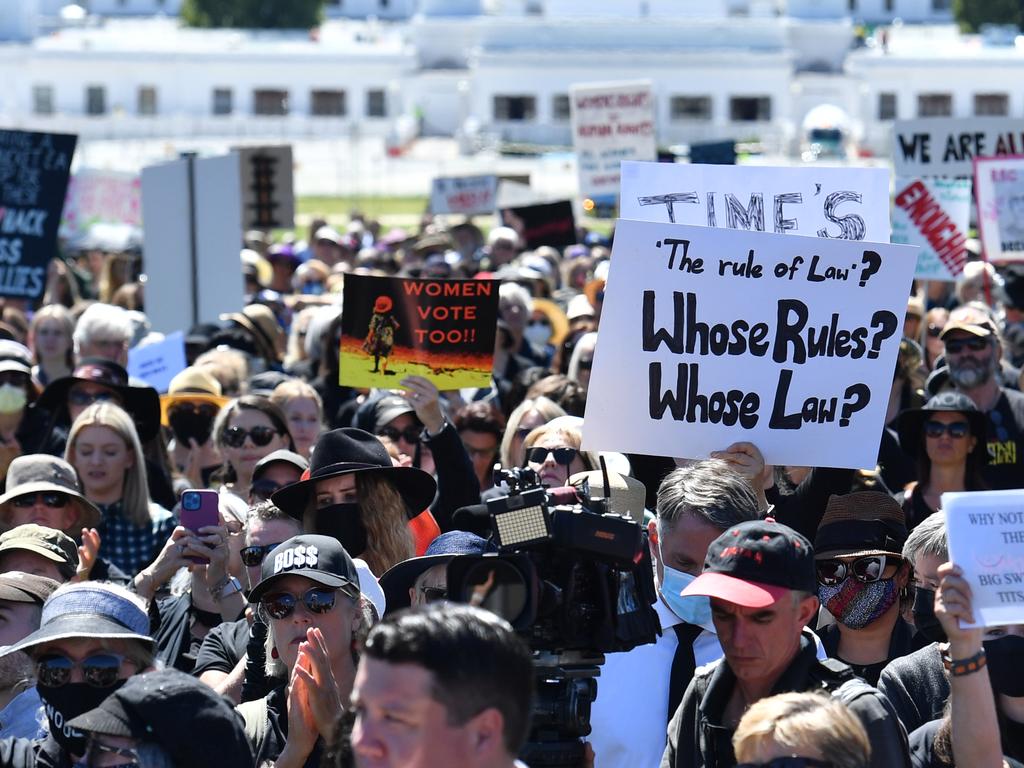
[447,459,660,768]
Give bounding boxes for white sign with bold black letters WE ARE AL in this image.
[893,118,1024,178]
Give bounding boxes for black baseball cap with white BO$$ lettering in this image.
[249,534,359,603]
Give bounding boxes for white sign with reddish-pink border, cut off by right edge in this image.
[974,158,1024,261]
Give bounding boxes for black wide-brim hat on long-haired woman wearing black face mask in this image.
[270,427,437,520]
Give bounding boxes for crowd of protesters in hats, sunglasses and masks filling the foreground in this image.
[0,210,1024,768]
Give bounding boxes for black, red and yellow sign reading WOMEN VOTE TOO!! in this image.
[338,274,498,390]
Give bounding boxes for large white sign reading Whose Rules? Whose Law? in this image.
[584,220,916,468]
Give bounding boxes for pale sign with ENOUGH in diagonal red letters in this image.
[891,178,971,282]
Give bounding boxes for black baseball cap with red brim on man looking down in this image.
[682,517,817,608]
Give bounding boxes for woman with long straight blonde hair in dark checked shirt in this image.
[65,402,174,577]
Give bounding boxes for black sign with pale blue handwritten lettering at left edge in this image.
[0,130,78,299]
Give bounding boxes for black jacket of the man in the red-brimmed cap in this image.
[662,633,910,768]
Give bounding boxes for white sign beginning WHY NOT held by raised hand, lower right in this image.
[942,490,1024,627]
